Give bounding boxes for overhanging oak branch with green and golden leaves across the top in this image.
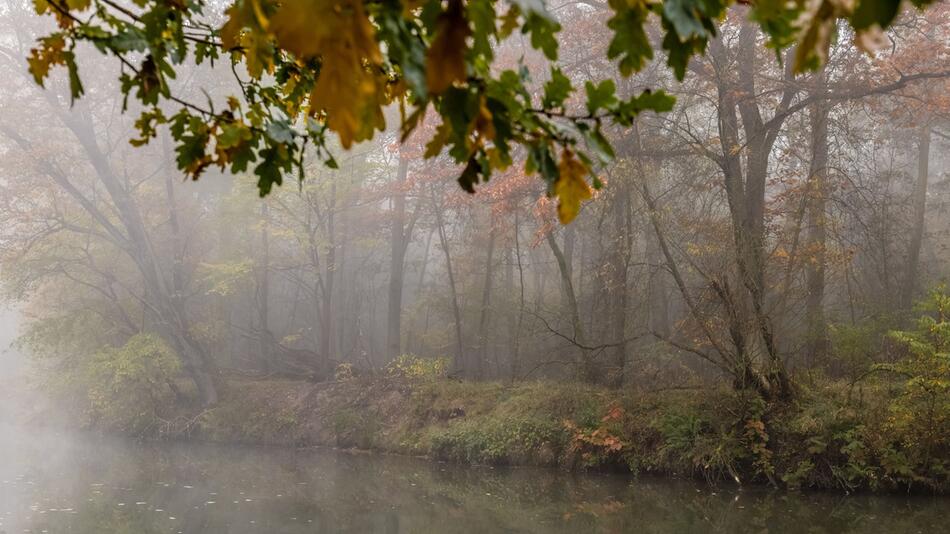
[29,0,928,223]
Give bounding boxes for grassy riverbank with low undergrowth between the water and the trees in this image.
[124,377,950,493]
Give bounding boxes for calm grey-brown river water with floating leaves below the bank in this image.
[0,426,950,534]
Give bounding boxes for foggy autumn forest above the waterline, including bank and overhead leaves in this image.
[0,0,950,520]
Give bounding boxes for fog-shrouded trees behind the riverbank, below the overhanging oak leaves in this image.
[0,3,950,396]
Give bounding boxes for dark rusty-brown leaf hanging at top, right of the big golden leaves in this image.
[426,0,471,95]
